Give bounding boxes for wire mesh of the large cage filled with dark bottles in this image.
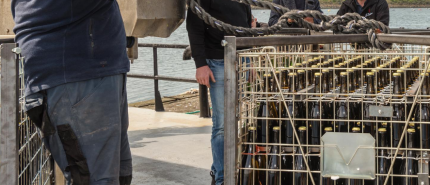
[238,44,430,185]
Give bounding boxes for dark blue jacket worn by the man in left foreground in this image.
[12,0,130,95]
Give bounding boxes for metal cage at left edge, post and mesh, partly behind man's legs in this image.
[0,44,60,185]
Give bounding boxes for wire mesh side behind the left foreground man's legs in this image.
[18,57,54,185]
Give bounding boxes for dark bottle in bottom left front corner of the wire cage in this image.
[241,127,260,185]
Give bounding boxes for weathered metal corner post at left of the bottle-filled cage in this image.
[223,36,238,185]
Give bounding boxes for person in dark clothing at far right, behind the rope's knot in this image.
[337,0,390,26]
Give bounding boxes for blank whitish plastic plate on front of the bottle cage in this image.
[321,132,375,179]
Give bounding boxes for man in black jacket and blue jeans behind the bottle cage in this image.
[187,0,252,185]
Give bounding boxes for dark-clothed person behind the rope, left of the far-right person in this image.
[269,0,322,27]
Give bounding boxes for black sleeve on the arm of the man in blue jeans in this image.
[186,0,210,68]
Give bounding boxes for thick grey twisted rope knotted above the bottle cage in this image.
[187,0,391,50]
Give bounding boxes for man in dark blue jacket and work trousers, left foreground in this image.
[12,0,132,185]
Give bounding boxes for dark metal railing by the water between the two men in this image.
[127,43,211,118]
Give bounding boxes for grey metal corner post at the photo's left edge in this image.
[0,44,19,185]
